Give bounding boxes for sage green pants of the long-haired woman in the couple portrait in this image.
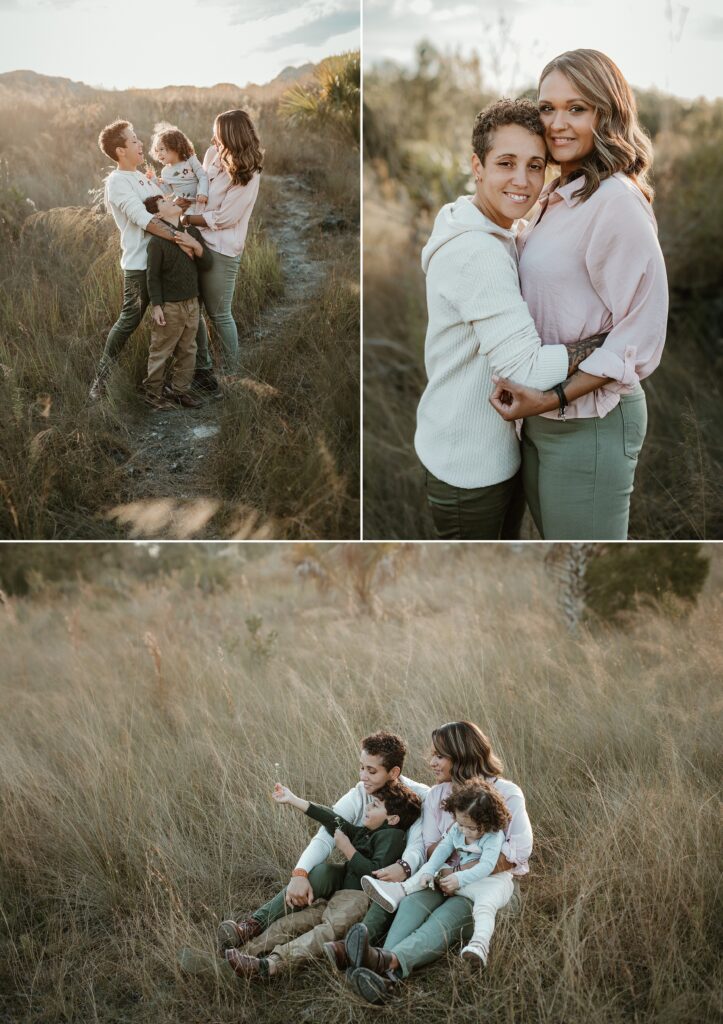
[522,387,647,541]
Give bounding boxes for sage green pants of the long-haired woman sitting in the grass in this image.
[384,889,474,978]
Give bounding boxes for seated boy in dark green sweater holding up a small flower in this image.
[224,781,422,978]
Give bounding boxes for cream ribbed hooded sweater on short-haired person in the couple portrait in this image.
[415,196,573,488]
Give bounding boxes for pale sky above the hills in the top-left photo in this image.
[0,0,360,89]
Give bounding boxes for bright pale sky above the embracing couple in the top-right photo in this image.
[364,0,723,99]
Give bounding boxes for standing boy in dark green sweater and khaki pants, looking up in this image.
[138,196,213,409]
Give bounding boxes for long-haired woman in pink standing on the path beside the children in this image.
[181,110,263,394]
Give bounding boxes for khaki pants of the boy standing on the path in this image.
[143,299,199,397]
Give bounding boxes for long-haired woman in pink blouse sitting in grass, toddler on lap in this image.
[329,721,533,1002]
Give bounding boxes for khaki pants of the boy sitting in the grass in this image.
[244,889,369,964]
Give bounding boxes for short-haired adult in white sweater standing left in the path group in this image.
[90,121,220,401]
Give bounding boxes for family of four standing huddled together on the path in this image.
[90,110,263,410]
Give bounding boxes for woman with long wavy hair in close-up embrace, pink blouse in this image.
[490,49,668,541]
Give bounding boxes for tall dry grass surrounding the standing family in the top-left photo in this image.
[0,69,359,540]
